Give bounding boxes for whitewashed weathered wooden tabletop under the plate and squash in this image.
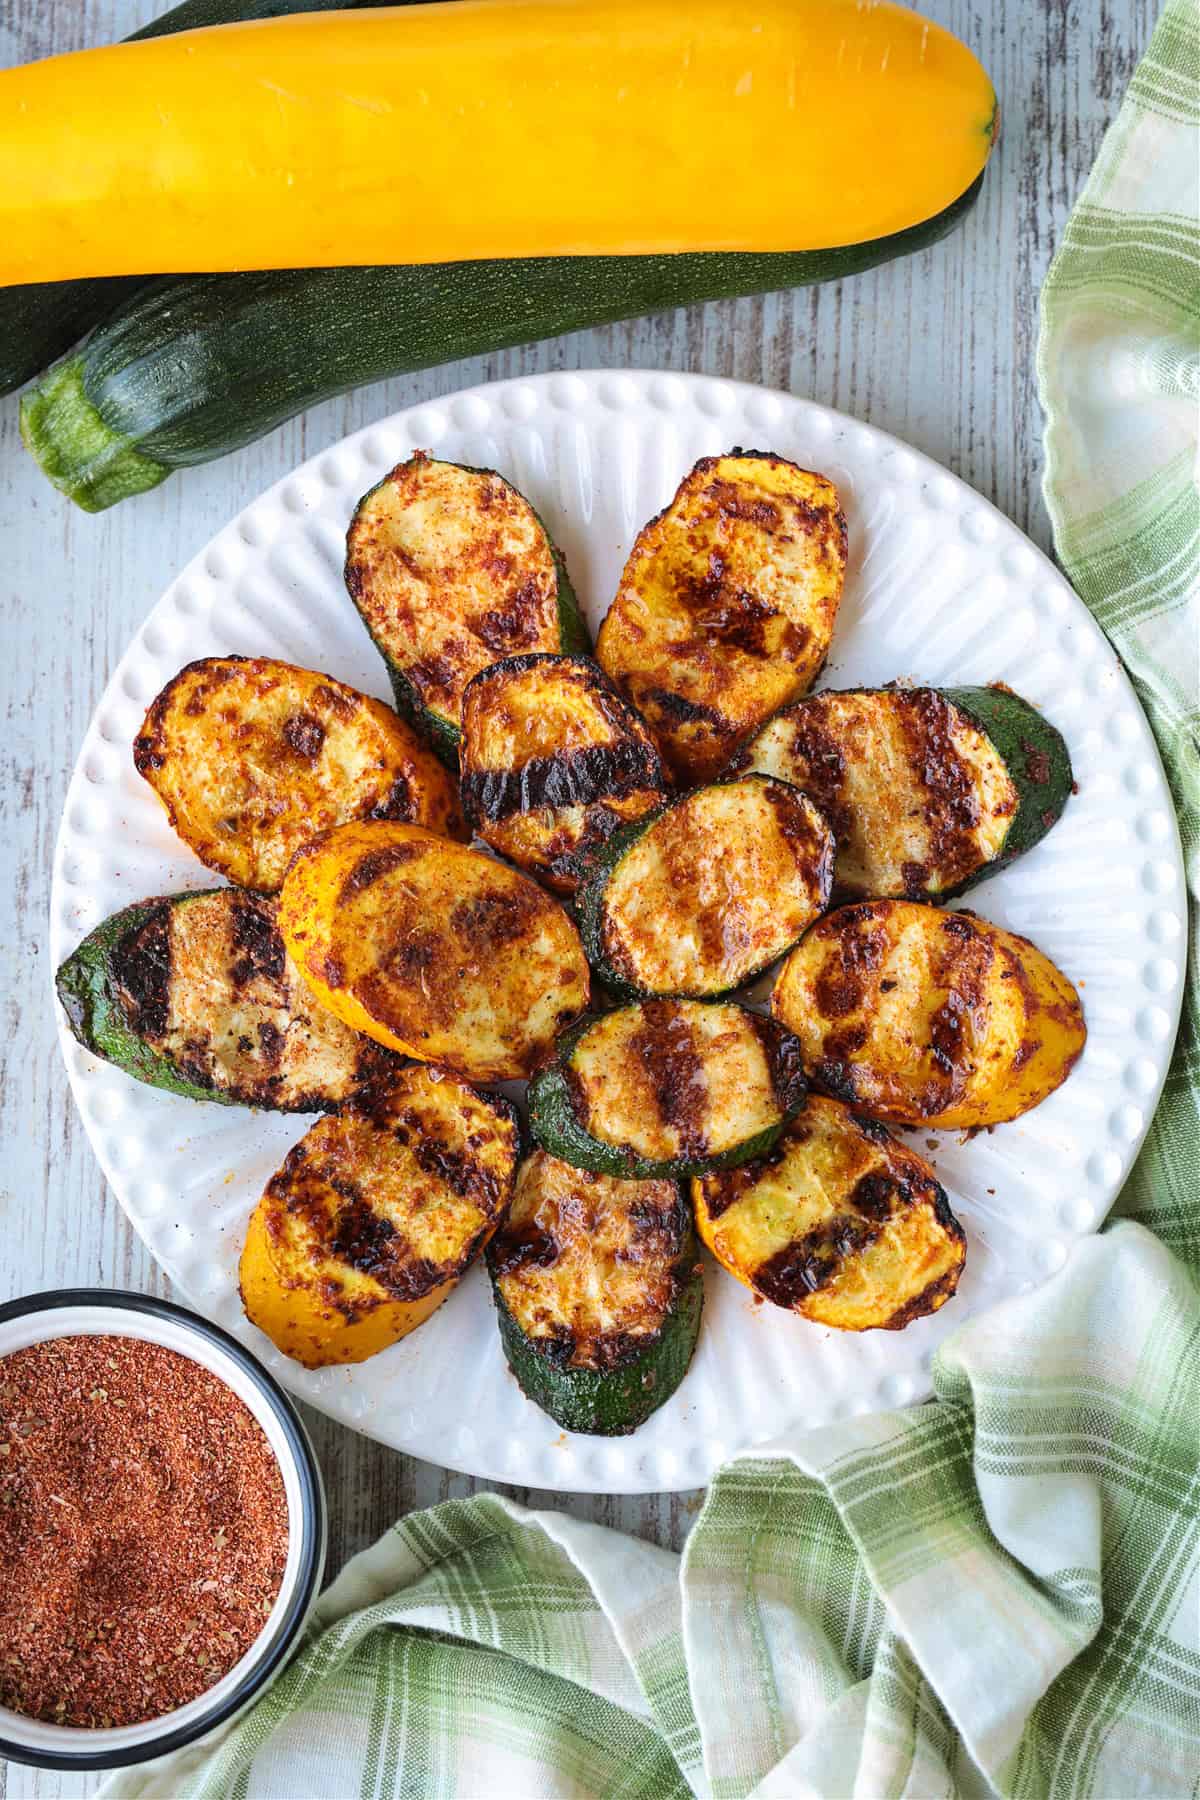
[0,0,1157,1800]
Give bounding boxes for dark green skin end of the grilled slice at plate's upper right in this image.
[939,688,1074,874]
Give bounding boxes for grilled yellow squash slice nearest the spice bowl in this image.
[241,1067,520,1368]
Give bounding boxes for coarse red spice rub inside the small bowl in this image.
[0,1337,288,1726]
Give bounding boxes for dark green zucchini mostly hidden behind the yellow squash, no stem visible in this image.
[0,0,407,394]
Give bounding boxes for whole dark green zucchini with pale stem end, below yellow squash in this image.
[22,175,982,511]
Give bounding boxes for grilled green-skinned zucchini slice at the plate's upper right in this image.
[730,688,1072,900]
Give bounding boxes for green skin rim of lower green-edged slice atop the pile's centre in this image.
[525,1003,808,1181]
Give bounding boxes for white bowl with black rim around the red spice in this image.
[0,1287,326,1769]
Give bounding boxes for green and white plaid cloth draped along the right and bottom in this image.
[106,0,1200,1800]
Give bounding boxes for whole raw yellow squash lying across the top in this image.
[0,0,995,284]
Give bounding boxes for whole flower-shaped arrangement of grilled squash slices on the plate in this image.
[58,450,1085,1435]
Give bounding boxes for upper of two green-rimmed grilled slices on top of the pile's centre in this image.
[578,774,833,999]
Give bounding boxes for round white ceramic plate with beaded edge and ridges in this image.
[50,373,1184,1494]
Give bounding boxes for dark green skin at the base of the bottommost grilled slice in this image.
[489,1229,703,1438]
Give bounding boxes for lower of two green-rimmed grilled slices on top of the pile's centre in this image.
[529,1001,804,1181]
